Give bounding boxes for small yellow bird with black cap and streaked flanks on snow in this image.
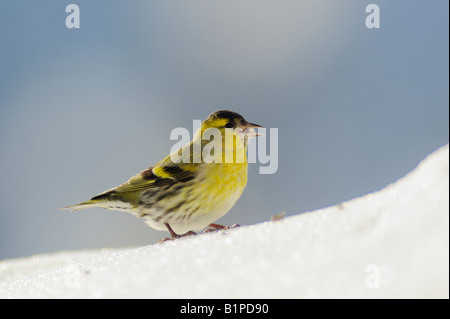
[62,110,262,238]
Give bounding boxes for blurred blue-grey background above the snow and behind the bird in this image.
[0,0,449,259]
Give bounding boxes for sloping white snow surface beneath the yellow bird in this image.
[0,145,449,298]
